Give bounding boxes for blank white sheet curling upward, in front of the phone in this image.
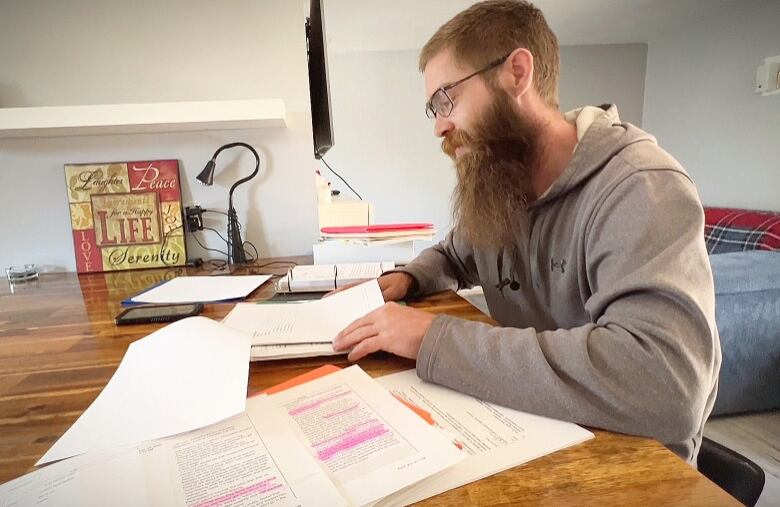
[37,317,250,464]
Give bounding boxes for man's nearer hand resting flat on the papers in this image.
[333,302,436,361]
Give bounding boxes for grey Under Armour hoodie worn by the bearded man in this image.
[399,106,721,463]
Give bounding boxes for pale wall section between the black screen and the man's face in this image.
[322,50,455,242]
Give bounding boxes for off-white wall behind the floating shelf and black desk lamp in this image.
[0,0,317,270]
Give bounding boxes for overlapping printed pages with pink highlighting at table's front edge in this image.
[0,366,466,506]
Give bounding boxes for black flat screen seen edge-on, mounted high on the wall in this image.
[306,0,333,160]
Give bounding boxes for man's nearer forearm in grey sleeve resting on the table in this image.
[417,294,716,443]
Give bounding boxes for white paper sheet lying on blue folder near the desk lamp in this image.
[131,275,271,304]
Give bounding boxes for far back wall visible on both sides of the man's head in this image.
[323,43,647,238]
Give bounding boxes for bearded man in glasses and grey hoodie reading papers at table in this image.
[334,0,720,462]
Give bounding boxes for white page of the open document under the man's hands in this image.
[222,280,385,346]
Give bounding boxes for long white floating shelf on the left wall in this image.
[0,99,287,138]
